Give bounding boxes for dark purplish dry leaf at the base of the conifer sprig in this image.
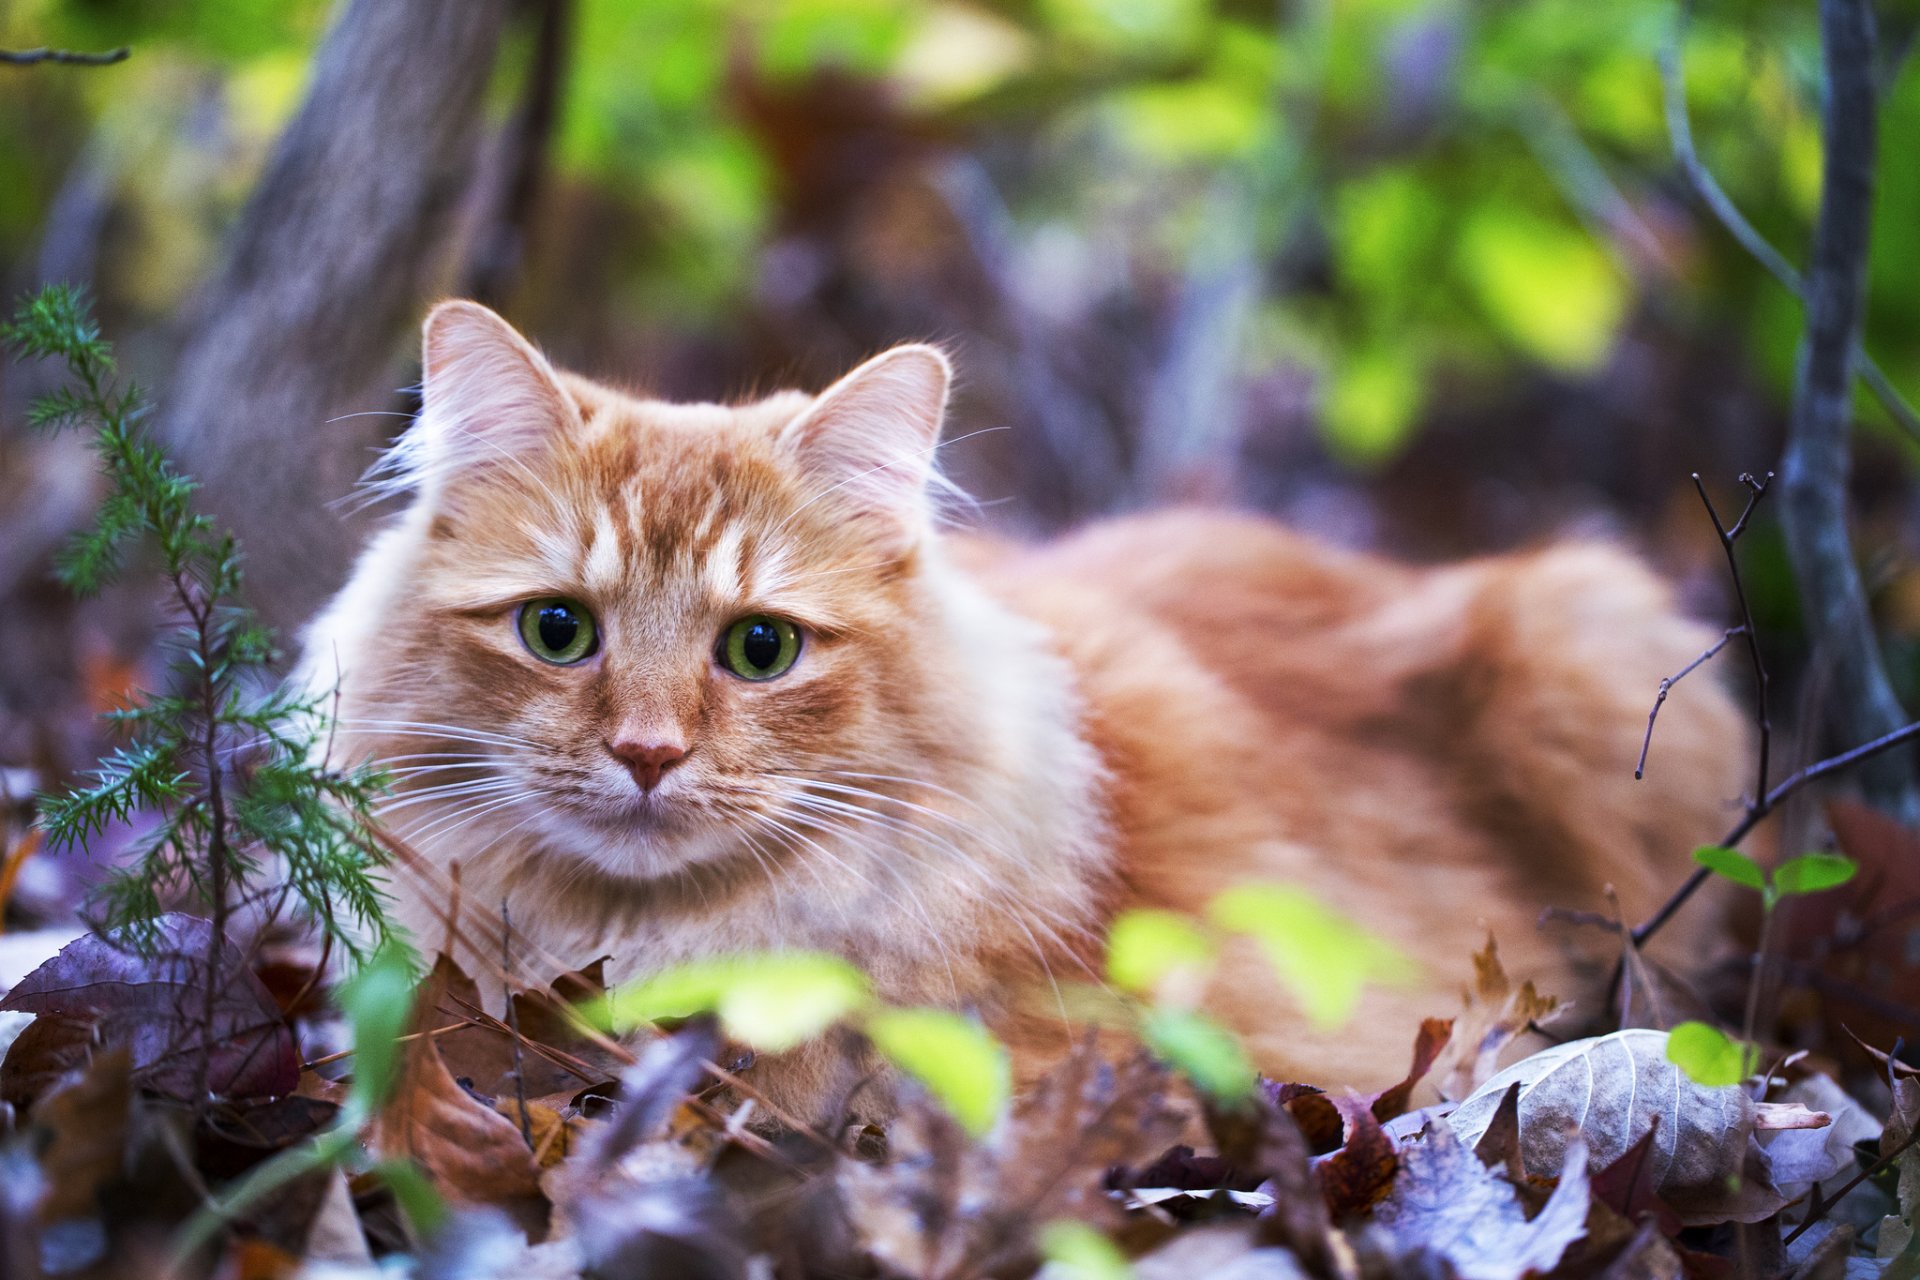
[0,912,300,1102]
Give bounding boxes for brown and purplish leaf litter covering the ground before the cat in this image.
[0,917,1920,1280]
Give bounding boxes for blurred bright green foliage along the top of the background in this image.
[11,0,1920,464]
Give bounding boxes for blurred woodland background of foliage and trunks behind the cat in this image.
[0,0,1920,832]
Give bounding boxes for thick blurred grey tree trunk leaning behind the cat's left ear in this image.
[161,0,513,631]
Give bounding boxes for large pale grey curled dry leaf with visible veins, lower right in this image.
[1450,1029,1827,1226]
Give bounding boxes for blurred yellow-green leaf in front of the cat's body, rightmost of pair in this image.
[1208,885,1417,1031]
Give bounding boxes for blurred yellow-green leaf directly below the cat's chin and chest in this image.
[609,952,868,1054]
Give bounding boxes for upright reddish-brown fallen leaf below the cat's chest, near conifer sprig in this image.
[372,956,540,1205]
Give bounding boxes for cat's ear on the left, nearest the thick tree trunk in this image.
[403,301,578,506]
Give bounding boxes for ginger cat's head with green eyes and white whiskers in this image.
[309,303,964,879]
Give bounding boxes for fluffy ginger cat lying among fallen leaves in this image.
[295,303,1745,1121]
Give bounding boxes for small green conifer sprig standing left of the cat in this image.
[0,286,386,974]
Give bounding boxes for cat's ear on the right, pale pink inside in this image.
[781,344,952,551]
